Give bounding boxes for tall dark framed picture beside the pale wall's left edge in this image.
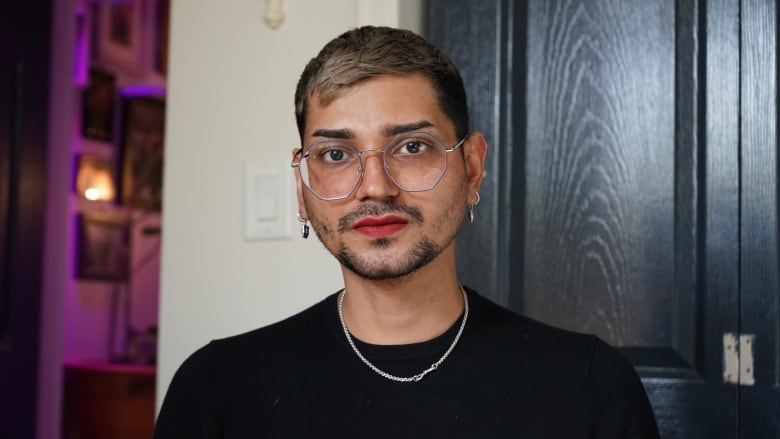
[120,96,165,210]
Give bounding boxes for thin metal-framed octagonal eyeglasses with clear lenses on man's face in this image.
[290,132,466,201]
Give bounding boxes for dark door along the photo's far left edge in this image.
[0,0,51,439]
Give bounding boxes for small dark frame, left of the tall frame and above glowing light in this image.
[81,69,116,142]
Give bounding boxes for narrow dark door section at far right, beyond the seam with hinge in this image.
[739,0,780,438]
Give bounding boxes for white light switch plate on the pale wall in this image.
[244,160,293,240]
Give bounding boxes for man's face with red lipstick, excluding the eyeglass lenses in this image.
[296,75,485,280]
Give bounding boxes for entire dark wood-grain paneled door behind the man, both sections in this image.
[429,0,780,438]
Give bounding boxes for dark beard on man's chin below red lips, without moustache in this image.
[334,238,443,280]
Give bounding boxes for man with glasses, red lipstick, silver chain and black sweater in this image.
[155,27,658,439]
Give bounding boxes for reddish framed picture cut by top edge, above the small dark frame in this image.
[94,0,142,70]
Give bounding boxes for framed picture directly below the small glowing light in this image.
[76,212,130,281]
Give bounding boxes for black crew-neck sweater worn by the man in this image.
[154,291,658,439]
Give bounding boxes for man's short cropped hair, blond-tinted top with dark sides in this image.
[295,26,469,143]
